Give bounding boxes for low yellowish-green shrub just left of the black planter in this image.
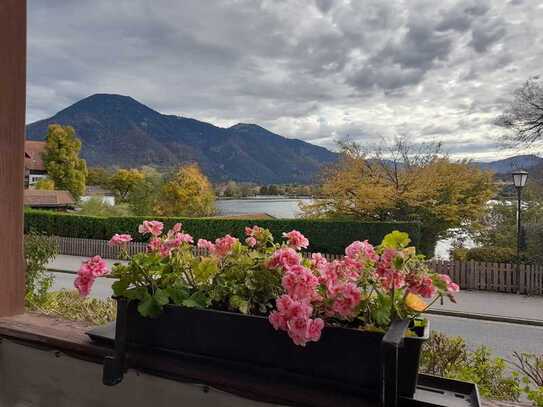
[31,290,117,325]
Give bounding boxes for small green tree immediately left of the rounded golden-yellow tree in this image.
[127,167,163,216]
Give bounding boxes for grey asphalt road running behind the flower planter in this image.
[53,273,543,359]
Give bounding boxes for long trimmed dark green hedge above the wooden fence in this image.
[25,210,426,253]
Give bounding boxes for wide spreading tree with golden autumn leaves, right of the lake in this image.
[302,139,495,252]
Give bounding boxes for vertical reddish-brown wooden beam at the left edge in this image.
[0,0,26,316]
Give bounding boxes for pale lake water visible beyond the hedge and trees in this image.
[217,197,464,259]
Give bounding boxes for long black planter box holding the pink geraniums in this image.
[121,302,429,398]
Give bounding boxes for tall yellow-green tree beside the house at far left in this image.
[43,124,87,200]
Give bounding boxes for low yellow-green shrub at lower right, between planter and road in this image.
[420,332,521,401]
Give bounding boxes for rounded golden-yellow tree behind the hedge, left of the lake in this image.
[156,164,215,217]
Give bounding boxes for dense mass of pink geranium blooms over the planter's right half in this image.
[267,231,459,346]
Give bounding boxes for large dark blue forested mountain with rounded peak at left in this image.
[26,94,337,184]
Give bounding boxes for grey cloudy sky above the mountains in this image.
[27,0,543,160]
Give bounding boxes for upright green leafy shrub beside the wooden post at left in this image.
[24,231,58,306]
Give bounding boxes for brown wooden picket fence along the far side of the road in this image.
[55,237,543,294]
